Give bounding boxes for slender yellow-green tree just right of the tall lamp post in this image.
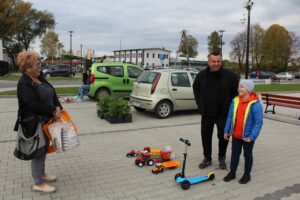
[250,24,265,70]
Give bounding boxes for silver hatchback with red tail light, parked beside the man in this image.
[130,69,197,119]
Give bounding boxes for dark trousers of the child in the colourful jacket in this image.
[230,138,254,175]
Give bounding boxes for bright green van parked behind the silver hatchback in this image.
[87,62,144,100]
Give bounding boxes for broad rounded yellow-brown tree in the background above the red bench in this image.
[262,24,293,72]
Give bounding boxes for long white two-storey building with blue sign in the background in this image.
[113,48,171,68]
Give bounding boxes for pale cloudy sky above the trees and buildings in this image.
[28,0,300,60]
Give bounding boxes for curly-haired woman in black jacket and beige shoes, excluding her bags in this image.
[15,51,62,192]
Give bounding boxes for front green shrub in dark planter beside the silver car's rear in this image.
[105,97,132,124]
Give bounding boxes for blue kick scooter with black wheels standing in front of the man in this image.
[175,138,215,190]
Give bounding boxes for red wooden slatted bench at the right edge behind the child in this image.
[261,93,300,120]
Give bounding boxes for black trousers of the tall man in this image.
[201,116,228,160]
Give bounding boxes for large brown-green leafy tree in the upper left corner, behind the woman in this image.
[0,0,55,69]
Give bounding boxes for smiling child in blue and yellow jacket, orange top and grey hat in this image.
[223,80,263,184]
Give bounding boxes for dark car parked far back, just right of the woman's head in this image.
[42,64,76,77]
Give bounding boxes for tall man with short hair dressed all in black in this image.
[193,53,238,169]
